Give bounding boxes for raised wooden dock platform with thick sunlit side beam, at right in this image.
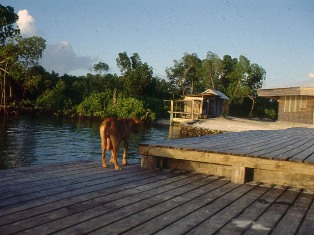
[140,128,314,190]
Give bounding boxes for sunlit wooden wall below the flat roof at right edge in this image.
[278,95,314,124]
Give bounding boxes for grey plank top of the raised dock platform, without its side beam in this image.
[141,128,314,164]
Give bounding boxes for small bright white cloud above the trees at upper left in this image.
[16,9,38,37]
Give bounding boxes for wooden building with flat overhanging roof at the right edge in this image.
[257,84,314,124]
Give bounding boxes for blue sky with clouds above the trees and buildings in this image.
[1,0,314,87]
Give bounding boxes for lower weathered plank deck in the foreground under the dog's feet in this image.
[0,160,314,235]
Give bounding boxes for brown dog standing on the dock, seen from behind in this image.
[100,118,141,170]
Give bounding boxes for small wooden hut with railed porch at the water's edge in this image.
[170,89,229,121]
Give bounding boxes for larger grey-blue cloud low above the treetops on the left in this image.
[40,41,95,75]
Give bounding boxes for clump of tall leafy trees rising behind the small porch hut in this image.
[166,51,266,115]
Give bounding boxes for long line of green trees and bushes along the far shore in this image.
[0,4,273,120]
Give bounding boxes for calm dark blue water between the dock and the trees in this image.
[0,116,178,169]
